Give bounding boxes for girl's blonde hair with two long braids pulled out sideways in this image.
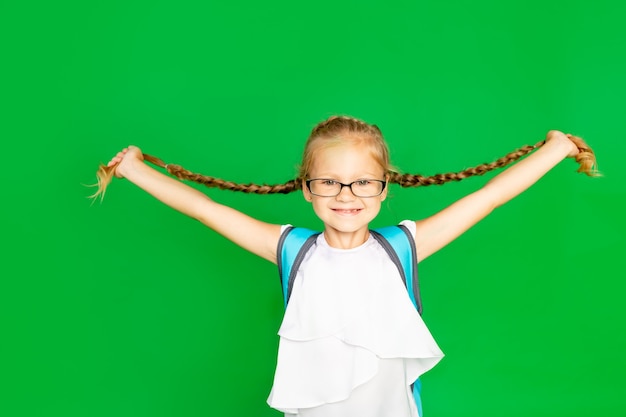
[90,116,600,198]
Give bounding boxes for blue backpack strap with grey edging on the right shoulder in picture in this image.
[370,225,422,314]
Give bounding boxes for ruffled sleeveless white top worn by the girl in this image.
[268,221,443,417]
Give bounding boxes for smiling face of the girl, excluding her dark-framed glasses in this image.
[302,143,387,245]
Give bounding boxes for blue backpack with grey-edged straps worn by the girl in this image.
[276,225,422,417]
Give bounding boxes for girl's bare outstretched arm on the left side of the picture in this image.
[108,146,280,263]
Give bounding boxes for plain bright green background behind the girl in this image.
[0,0,626,417]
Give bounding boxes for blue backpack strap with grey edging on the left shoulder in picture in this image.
[276,226,319,306]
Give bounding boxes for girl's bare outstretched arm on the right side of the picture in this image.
[415,131,578,261]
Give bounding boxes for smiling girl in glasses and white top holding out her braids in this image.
[94,116,596,417]
